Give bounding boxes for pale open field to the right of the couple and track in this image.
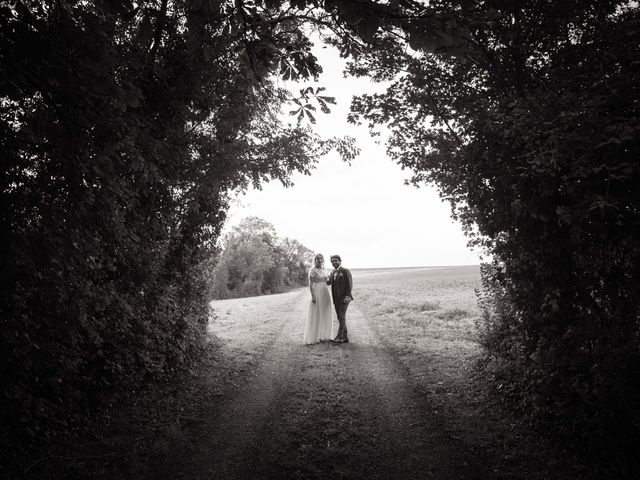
[353,266,481,422]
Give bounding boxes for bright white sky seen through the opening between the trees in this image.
[225,40,480,268]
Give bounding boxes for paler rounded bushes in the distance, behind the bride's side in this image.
[213,217,313,298]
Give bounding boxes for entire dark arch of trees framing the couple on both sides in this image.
[0,0,640,476]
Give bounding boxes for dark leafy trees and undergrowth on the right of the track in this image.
[336,0,640,473]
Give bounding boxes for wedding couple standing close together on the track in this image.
[304,254,353,345]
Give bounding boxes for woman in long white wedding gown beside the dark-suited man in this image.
[304,253,331,345]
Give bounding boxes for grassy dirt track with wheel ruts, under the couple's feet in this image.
[154,290,536,479]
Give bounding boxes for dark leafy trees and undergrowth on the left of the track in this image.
[0,0,353,460]
